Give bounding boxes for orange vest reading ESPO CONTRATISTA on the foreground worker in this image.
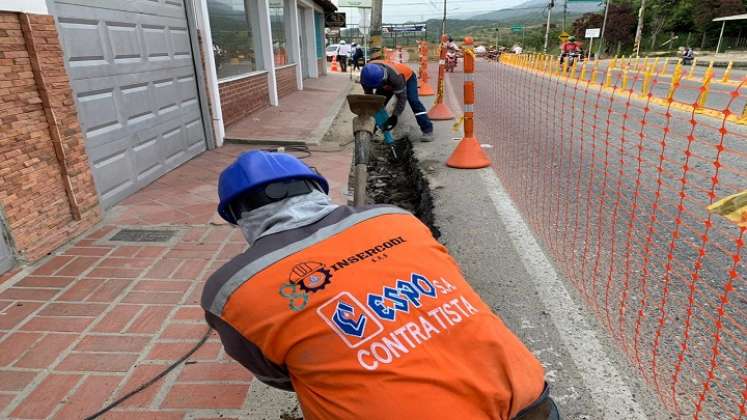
[203,207,544,420]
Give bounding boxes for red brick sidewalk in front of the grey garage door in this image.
[0,145,351,419]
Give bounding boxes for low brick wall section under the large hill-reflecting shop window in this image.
[218,73,270,125]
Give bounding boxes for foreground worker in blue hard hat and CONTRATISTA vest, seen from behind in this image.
[202,151,558,420]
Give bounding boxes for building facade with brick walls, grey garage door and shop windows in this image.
[0,0,334,274]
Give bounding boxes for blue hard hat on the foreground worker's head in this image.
[218,150,329,224]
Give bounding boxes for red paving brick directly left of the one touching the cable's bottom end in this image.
[11,373,82,419]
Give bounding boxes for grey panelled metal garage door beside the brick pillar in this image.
[49,0,206,208]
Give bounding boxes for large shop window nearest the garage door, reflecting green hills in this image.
[207,0,262,79]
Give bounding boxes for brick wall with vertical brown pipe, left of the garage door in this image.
[0,12,101,261]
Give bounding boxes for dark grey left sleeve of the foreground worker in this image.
[205,311,293,391]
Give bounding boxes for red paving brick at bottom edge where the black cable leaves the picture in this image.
[54,375,123,420]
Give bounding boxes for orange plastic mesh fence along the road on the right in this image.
[462,55,747,419]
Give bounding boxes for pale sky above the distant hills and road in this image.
[333,0,526,24]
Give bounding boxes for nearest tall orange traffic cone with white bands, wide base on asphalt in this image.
[446,36,490,169]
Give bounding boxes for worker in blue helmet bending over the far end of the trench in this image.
[361,60,433,142]
